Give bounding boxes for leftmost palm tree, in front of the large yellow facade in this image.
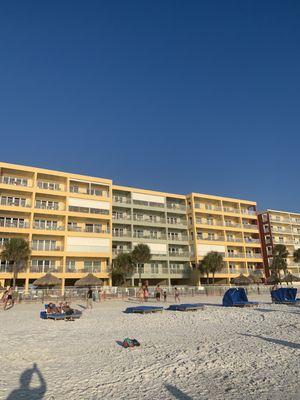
[1,238,31,287]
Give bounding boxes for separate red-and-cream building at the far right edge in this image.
[258,209,300,277]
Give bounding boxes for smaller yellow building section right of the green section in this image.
[187,193,263,283]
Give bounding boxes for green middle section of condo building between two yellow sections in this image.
[112,185,190,285]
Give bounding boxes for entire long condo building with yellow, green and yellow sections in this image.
[0,162,263,289]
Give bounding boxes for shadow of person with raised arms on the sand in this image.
[6,364,47,400]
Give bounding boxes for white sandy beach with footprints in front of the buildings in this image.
[0,296,300,400]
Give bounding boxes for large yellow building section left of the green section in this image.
[0,162,112,289]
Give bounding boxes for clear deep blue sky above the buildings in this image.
[0,0,300,211]
